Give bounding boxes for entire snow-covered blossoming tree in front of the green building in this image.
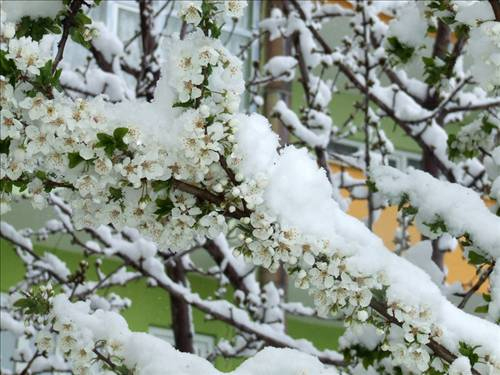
[0,0,500,375]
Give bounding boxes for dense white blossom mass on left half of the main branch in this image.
[0,16,243,254]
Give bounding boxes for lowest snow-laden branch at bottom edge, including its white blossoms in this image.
[47,295,337,375]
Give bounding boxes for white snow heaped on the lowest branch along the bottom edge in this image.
[53,295,337,375]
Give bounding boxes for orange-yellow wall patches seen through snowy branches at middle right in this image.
[331,164,488,293]
